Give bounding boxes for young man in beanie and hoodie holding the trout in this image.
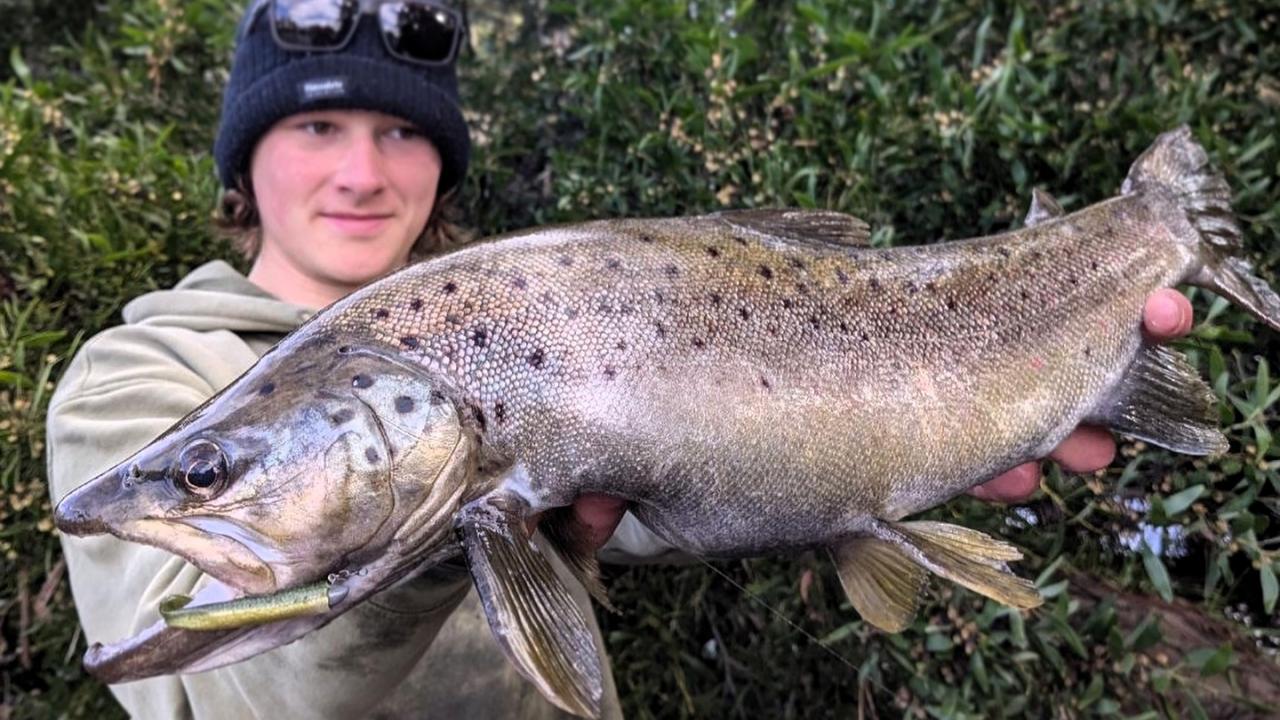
[49,0,1190,717]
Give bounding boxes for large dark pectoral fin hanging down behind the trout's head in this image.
[457,493,603,717]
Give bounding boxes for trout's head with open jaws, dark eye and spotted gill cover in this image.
[55,334,476,682]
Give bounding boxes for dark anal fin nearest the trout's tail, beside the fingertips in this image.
[1101,345,1228,455]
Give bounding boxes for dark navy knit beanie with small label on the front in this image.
[214,3,471,193]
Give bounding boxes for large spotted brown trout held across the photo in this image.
[56,128,1280,716]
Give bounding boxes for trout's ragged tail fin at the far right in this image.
[1120,126,1280,331]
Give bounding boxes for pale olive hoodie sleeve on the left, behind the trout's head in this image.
[47,327,481,719]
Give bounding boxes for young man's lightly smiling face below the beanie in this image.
[250,110,440,295]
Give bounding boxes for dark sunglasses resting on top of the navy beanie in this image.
[248,0,466,65]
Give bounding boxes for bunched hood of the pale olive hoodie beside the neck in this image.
[123,260,315,333]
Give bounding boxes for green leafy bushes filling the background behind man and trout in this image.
[0,0,1280,720]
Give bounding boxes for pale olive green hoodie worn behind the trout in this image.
[49,261,640,719]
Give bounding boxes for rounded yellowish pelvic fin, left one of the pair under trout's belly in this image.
[831,536,928,633]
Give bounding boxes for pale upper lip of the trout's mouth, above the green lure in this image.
[120,516,280,594]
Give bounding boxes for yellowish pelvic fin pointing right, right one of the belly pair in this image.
[870,520,1043,607]
